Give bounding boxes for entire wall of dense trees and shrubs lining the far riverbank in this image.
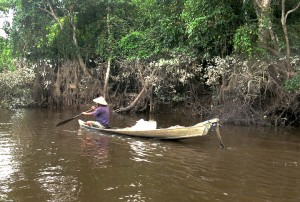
[0,0,300,125]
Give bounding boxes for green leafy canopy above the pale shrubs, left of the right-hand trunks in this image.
[7,0,244,60]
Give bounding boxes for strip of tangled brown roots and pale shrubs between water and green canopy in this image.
[0,57,300,126]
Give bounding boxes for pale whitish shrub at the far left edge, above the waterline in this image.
[0,67,35,108]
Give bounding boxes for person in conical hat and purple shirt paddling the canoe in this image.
[82,96,110,128]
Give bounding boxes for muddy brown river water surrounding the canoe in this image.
[0,109,300,202]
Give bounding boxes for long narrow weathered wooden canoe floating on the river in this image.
[78,118,219,139]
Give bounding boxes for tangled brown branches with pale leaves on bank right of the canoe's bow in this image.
[205,56,300,125]
